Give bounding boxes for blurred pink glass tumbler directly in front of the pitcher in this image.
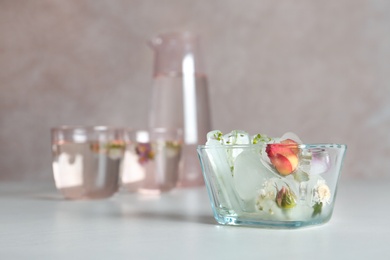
[121,128,182,194]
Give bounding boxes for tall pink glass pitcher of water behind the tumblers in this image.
[149,32,211,187]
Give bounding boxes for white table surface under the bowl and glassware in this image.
[0,180,390,260]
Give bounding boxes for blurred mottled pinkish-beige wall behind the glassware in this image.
[0,0,390,180]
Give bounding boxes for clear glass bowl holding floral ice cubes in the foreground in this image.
[197,144,346,228]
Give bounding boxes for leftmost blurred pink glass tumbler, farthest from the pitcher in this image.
[51,126,125,199]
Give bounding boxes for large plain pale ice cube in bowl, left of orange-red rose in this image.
[233,150,274,200]
